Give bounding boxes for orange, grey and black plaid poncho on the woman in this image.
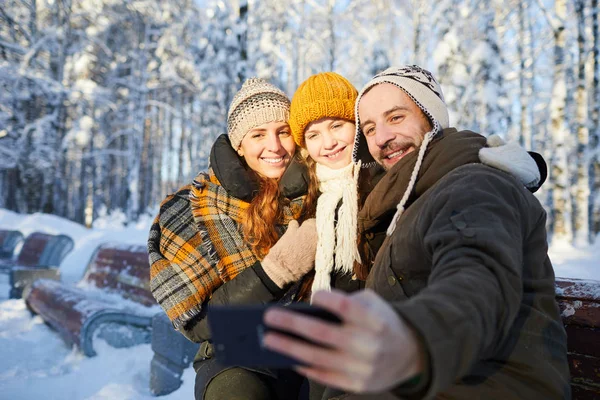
[148,170,304,329]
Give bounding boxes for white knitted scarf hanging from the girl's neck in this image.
[312,163,360,293]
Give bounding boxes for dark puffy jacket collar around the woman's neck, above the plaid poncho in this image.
[210,134,308,202]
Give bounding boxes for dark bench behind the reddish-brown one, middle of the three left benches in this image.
[9,232,74,299]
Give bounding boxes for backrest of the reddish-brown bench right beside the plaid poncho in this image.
[82,243,156,306]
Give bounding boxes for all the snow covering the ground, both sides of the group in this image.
[0,209,600,400]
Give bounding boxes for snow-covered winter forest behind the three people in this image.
[0,0,600,244]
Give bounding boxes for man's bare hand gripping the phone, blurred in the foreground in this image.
[264,290,425,393]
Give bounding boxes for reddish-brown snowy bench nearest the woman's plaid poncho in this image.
[23,243,158,357]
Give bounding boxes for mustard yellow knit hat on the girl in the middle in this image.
[288,72,358,147]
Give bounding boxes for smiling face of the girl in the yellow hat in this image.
[304,118,356,169]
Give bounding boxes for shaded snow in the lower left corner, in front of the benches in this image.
[0,290,195,400]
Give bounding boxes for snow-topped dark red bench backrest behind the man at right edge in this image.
[556,278,600,400]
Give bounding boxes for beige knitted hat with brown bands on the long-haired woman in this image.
[227,78,290,150]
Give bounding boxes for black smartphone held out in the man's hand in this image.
[208,303,341,368]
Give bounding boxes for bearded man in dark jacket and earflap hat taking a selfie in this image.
[265,66,570,399]
